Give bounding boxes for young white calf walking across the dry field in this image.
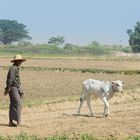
[78,79,123,117]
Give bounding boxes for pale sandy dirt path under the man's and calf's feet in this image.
[0,97,140,138]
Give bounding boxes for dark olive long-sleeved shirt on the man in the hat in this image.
[5,65,21,90]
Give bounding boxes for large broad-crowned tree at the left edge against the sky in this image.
[0,20,31,44]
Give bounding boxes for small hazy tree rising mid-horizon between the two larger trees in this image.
[48,36,65,46]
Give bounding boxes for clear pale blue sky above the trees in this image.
[0,0,140,46]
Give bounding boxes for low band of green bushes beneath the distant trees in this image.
[0,43,131,57]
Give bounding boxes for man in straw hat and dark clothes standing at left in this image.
[4,55,26,127]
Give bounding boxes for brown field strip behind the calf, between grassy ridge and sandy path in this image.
[0,70,140,107]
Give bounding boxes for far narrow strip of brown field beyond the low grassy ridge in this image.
[0,58,140,70]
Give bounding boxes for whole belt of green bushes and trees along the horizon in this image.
[0,19,140,53]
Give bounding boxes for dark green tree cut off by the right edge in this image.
[127,22,140,52]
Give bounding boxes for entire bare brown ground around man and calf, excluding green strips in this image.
[0,58,140,140]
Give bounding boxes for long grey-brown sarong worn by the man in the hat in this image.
[9,86,21,122]
